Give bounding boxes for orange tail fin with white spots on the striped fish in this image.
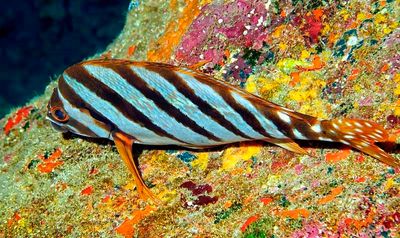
[321,119,400,167]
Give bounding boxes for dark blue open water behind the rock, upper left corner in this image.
[0,0,130,118]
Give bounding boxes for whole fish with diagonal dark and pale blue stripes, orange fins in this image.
[47,59,400,200]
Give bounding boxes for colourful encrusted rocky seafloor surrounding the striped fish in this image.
[0,0,400,237]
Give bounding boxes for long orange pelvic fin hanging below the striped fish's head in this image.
[112,132,160,204]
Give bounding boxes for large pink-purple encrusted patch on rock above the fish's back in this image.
[176,0,269,65]
